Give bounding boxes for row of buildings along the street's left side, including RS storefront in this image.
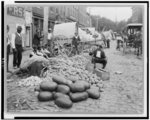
[5,5,91,47]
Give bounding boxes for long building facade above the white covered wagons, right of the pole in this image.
[50,5,91,27]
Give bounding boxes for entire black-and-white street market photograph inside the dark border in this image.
[4,2,147,117]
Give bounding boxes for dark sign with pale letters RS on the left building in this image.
[7,6,24,18]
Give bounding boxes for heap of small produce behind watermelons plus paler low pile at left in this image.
[17,55,103,88]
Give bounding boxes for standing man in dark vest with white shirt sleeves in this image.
[12,26,23,68]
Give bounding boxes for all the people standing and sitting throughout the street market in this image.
[7,25,142,72]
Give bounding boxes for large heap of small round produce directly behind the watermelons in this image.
[47,55,102,86]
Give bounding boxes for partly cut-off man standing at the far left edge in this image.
[6,25,11,72]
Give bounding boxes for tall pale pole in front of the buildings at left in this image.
[43,6,49,45]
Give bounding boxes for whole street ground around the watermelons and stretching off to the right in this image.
[7,41,144,114]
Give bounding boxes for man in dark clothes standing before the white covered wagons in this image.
[72,33,80,54]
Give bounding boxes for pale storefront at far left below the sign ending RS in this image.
[5,6,32,48]
